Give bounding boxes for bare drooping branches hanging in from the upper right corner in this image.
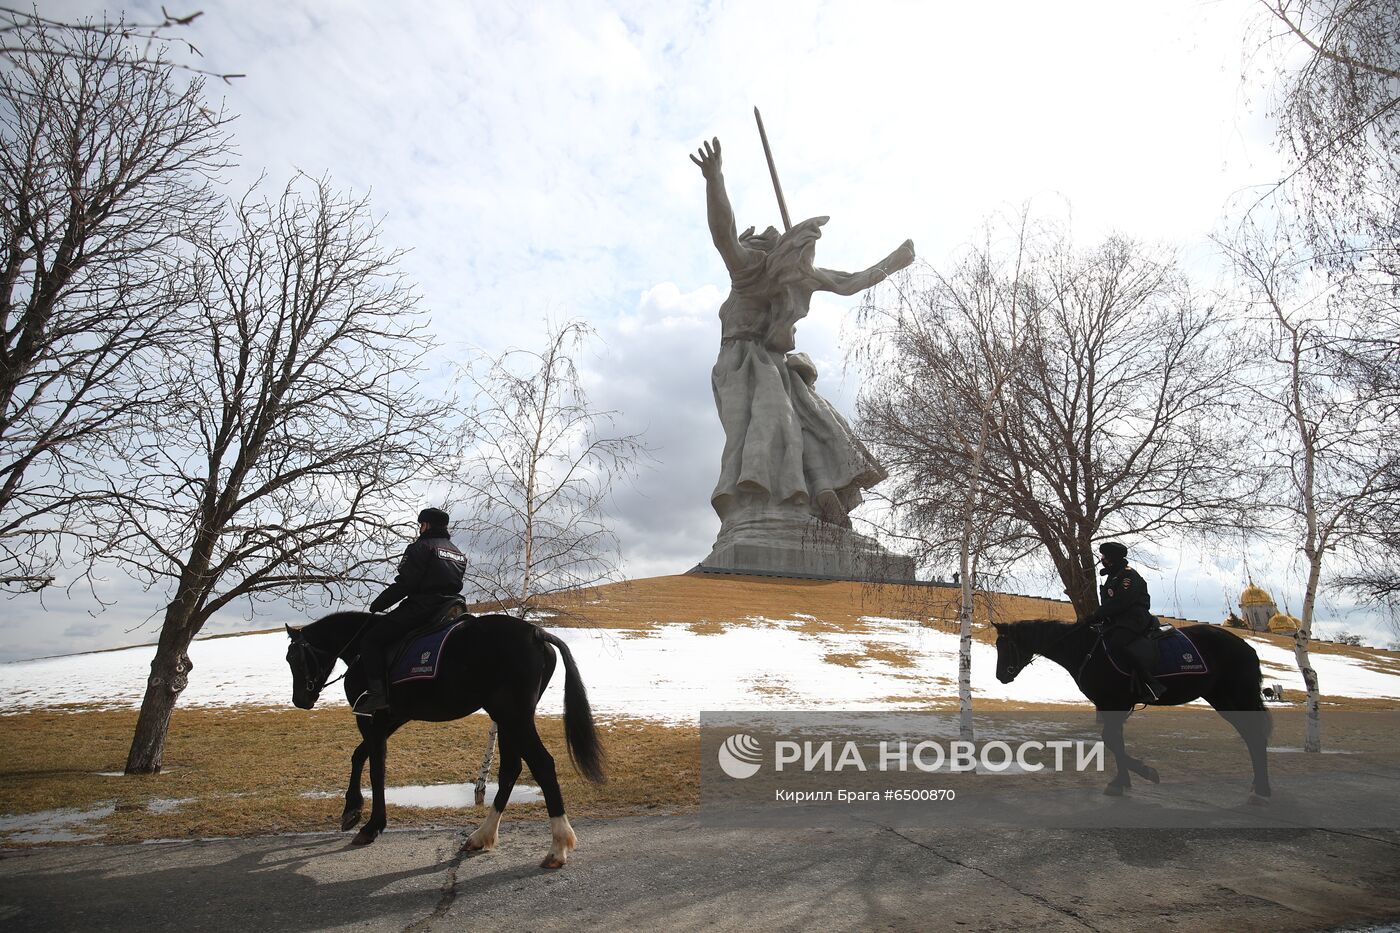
[1236,0,1400,636]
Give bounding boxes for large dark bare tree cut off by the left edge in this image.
[0,19,228,590]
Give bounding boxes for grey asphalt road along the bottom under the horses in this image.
[0,817,1400,933]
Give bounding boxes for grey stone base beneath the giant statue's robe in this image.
[696,507,914,583]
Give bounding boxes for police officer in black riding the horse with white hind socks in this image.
[354,509,466,716]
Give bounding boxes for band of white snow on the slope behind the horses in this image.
[0,618,1400,721]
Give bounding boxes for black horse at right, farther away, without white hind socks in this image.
[995,619,1270,803]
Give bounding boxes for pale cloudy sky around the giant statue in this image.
[8,0,1388,658]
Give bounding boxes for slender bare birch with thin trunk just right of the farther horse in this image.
[1222,226,1400,752]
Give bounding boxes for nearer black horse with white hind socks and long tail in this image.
[287,612,603,869]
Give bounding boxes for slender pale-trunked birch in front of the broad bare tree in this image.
[860,212,1029,740]
